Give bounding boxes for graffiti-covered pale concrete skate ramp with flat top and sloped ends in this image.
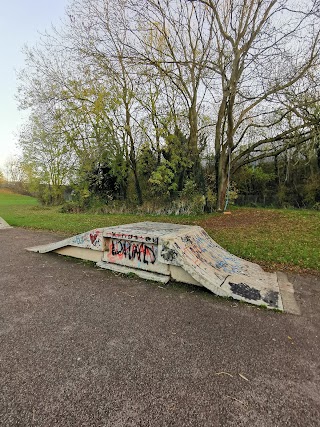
[28,222,297,312]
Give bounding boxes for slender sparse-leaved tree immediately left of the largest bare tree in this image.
[128,0,212,175]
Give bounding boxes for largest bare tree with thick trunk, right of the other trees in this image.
[192,0,319,210]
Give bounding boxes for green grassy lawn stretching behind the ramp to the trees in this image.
[0,190,320,274]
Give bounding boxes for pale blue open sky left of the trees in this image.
[0,0,68,169]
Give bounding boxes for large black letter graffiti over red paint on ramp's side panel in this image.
[110,240,156,264]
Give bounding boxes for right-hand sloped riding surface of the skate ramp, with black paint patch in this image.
[161,227,283,310]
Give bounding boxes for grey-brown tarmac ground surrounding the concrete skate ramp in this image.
[0,228,320,427]
